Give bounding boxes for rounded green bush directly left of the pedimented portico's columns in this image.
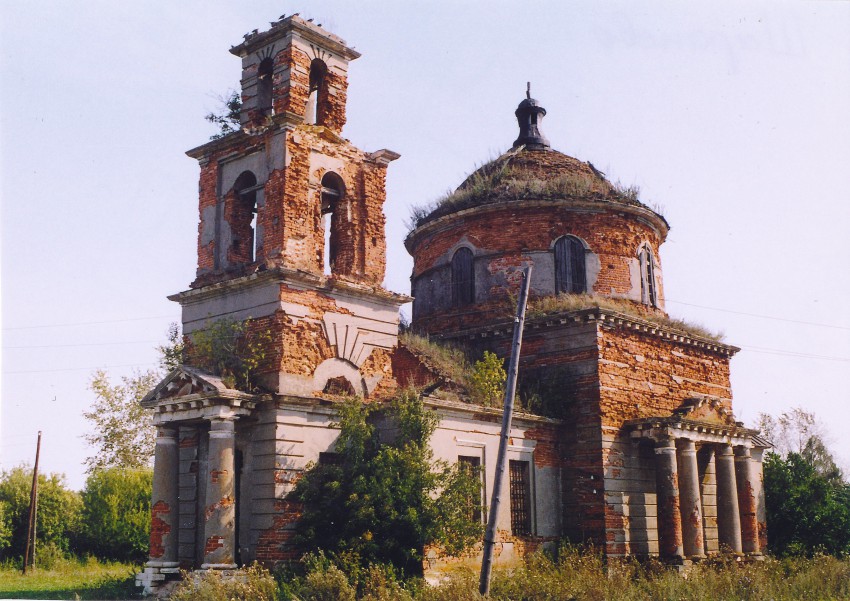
[77,467,153,561]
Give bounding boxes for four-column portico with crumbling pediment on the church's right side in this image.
[627,415,766,562]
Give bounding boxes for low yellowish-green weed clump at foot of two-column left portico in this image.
[169,564,278,601]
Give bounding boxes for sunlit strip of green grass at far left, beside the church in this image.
[0,558,141,599]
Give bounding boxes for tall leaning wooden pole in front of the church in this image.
[478,265,531,595]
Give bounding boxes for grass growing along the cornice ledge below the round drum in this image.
[528,294,723,342]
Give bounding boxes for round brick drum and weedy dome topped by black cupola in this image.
[405,89,669,333]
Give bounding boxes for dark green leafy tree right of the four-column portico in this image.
[764,452,850,556]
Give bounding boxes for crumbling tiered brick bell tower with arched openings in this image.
[175,15,407,397]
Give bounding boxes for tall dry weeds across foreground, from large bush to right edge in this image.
[264,547,850,601]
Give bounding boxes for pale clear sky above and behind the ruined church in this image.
[0,0,850,488]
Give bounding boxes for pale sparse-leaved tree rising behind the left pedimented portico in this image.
[83,370,160,473]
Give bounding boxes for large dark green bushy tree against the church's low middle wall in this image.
[291,392,476,575]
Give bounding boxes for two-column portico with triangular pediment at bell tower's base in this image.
[137,367,257,588]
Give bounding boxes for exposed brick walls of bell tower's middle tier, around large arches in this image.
[193,111,386,287]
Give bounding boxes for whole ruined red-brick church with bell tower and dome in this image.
[138,16,767,590]
